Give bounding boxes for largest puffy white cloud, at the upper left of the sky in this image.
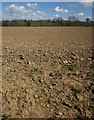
[8,4,30,13]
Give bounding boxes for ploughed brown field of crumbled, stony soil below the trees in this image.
[2,27,94,118]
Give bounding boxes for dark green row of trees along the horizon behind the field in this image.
[0,17,94,27]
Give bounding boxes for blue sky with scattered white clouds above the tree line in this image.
[0,0,92,21]
